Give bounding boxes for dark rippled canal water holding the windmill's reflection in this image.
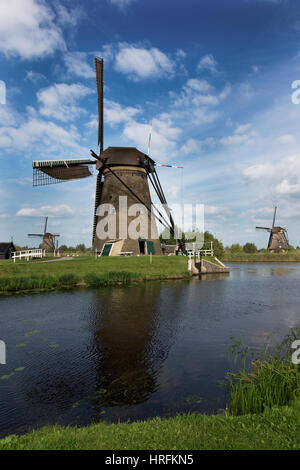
[0,263,300,436]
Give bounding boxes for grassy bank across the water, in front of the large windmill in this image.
[0,256,188,292]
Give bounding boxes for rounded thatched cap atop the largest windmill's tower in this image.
[96,147,155,170]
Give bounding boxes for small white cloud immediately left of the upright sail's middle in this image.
[37,83,94,122]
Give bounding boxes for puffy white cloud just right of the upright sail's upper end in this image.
[115,43,174,80]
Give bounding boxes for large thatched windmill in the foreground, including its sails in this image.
[33,58,182,256]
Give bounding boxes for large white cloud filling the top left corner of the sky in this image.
[0,0,66,59]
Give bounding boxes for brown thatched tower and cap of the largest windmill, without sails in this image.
[93,147,162,255]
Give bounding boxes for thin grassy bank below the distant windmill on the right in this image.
[222,250,300,263]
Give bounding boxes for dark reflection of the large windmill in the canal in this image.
[90,283,183,408]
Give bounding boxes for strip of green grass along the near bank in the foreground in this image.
[0,401,300,450]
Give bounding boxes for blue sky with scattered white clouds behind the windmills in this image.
[0,0,300,248]
